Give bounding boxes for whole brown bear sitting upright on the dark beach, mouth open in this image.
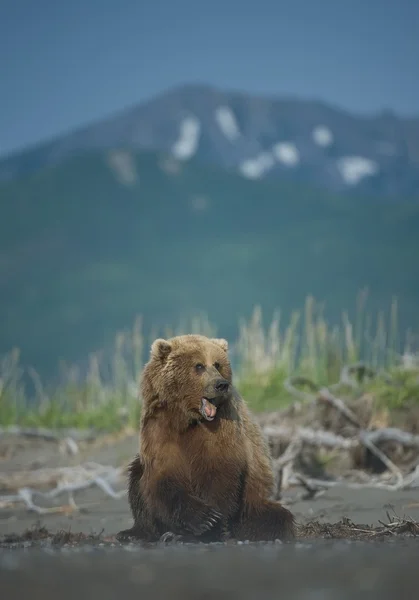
[118,335,295,542]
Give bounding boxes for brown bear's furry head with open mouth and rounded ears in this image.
[141,335,233,424]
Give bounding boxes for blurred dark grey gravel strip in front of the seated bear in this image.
[0,538,419,600]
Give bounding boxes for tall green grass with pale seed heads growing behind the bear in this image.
[0,296,419,431]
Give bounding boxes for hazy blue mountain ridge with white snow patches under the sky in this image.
[0,85,419,200]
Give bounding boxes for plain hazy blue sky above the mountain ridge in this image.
[0,0,419,154]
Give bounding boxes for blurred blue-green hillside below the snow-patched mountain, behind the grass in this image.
[0,147,419,374]
